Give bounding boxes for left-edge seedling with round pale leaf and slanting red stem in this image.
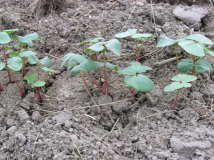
[0,57,24,98]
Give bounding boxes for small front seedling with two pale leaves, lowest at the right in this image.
[164,74,197,110]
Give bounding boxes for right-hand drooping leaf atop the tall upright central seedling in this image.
[105,39,121,56]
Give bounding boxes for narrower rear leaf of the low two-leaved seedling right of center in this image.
[119,62,152,76]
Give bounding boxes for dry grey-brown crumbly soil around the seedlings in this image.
[0,0,214,160]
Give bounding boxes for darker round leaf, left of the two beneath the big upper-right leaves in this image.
[178,59,195,73]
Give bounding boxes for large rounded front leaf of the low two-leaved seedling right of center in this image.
[125,74,154,92]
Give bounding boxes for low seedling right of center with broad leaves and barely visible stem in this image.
[119,62,154,101]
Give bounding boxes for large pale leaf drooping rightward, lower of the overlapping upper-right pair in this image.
[178,40,205,57]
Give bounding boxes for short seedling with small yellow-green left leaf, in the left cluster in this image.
[24,73,45,103]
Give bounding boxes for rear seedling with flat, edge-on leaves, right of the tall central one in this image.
[115,29,153,62]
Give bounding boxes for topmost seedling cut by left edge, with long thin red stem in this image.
[0,29,18,83]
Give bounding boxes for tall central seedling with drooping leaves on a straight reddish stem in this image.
[85,39,121,94]
